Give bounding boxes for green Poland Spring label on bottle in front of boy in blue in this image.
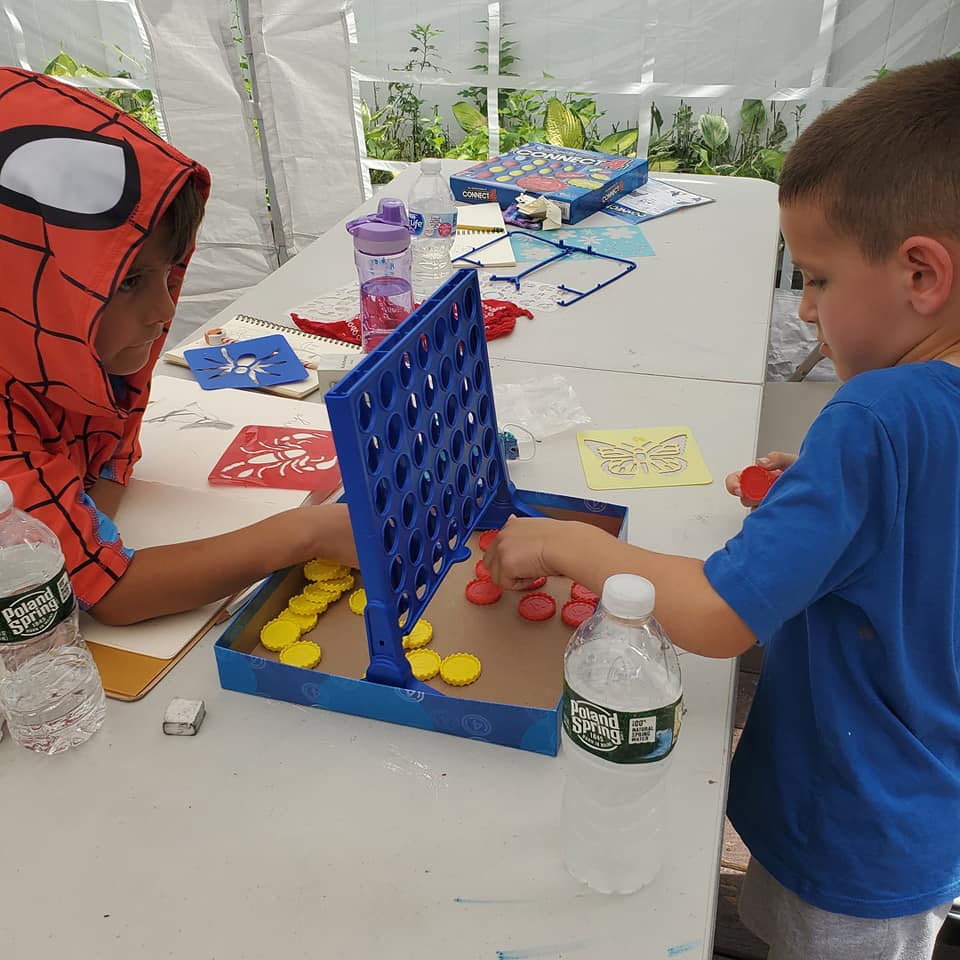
[563,684,683,763]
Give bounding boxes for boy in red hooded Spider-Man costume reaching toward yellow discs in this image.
[0,68,357,624]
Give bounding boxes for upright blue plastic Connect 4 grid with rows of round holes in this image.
[325,270,539,694]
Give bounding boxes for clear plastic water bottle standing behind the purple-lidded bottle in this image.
[407,157,457,300]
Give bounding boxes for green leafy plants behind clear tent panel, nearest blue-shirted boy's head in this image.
[647,100,806,181]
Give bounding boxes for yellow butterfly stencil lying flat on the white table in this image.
[577,427,712,490]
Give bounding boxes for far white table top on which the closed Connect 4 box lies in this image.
[197,161,779,383]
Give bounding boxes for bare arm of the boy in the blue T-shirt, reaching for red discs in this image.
[483,517,756,657]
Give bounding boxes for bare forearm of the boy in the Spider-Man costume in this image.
[89,504,357,626]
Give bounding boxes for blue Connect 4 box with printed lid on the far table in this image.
[450,143,647,223]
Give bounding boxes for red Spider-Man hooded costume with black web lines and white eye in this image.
[0,68,209,606]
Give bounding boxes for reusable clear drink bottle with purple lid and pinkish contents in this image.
[347,197,413,353]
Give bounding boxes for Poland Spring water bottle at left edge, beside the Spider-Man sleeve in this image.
[0,481,106,754]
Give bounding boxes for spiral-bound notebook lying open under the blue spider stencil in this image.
[163,313,363,399]
